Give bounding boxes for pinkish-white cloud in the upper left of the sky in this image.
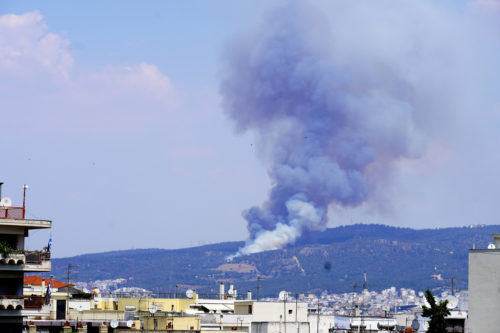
[0,11,176,133]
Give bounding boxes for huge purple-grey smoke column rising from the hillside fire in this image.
[221,1,478,259]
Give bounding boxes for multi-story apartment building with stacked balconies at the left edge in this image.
[0,183,52,333]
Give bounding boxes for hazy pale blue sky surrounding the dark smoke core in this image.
[0,0,500,257]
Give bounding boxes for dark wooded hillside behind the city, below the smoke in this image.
[48,224,500,295]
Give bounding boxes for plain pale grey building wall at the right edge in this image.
[469,249,500,333]
